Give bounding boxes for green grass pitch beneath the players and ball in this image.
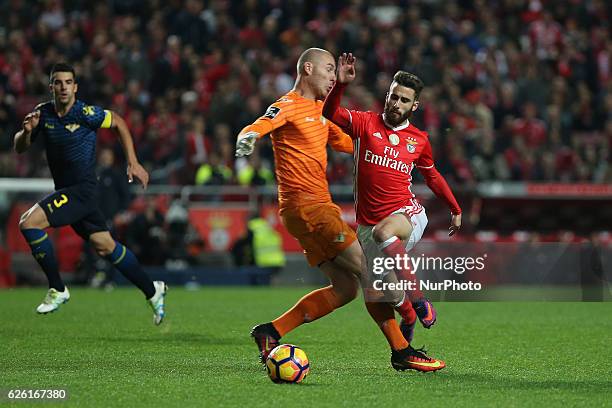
[0,288,612,407]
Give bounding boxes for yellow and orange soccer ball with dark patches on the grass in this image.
[266,344,310,383]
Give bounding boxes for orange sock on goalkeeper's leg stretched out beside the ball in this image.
[272,285,341,337]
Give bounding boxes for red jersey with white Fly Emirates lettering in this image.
[346,110,434,225]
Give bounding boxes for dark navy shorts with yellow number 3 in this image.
[38,183,109,240]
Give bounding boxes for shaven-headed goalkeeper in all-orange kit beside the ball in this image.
[236,48,363,362]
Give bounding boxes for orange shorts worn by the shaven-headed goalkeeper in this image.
[280,203,357,266]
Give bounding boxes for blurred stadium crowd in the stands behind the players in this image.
[0,0,612,185]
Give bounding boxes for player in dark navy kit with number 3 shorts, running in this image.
[14,63,166,324]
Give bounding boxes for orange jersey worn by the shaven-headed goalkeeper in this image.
[241,91,353,210]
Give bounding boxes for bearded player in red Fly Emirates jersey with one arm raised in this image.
[323,54,461,370]
